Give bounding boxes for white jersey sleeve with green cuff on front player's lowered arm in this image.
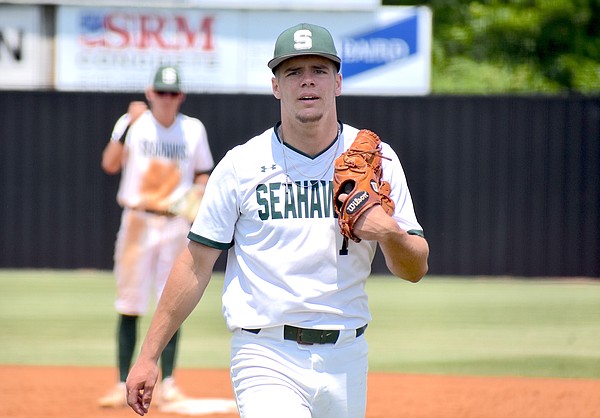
[188,151,239,250]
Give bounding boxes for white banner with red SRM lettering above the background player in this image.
[56,7,243,91]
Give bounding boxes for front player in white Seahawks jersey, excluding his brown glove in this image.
[127,24,429,418]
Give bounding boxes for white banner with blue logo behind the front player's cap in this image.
[245,7,431,95]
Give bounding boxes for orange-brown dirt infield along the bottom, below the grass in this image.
[0,366,600,418]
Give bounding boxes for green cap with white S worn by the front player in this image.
[267,23,342,72]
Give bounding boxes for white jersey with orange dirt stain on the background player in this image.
[112,110,214,210]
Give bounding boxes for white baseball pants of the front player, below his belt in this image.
[231,326,368,418]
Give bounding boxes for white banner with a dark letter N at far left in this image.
[0,4,52,89]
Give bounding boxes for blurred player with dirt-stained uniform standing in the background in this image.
[99,66,214,407]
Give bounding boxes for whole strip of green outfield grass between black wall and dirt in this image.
[0,270,600,379]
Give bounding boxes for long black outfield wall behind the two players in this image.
[0,91,600,277]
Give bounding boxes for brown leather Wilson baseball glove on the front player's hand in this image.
[333,129,395,255]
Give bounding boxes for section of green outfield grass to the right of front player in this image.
[368,277,600,378]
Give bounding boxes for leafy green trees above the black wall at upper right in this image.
[382,0,600,94]
